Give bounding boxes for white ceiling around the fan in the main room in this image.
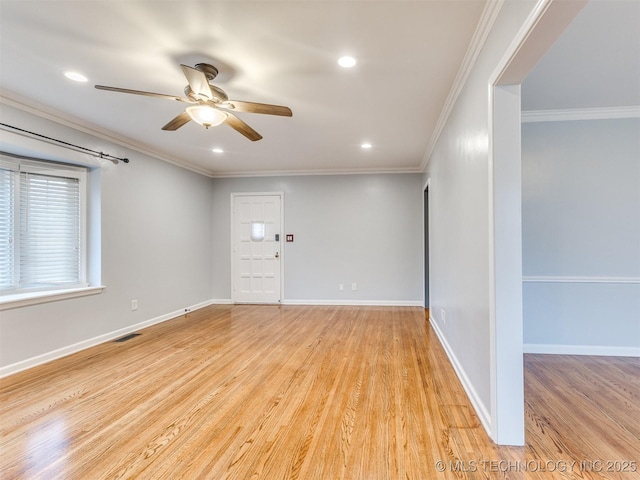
[0,0,485,175]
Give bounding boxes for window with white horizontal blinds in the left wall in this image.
[0,156,87,294]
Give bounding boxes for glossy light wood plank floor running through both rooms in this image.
[0,306,640,480]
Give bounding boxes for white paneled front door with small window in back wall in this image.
[231,193,282,303]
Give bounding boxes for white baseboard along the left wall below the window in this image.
[0,300,214,378]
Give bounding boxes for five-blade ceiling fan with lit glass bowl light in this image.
[96,63,293,142]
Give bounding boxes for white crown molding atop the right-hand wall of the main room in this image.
[420,0,505,172]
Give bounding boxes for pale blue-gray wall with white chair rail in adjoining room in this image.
[522,118,640,354]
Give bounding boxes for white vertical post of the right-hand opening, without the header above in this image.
[487,84,525,445]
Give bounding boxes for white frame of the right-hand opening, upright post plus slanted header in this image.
[487,0,587,445]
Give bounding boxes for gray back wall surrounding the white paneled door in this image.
[213,174,423,305]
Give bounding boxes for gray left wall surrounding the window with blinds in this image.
[0,105,212,374]
